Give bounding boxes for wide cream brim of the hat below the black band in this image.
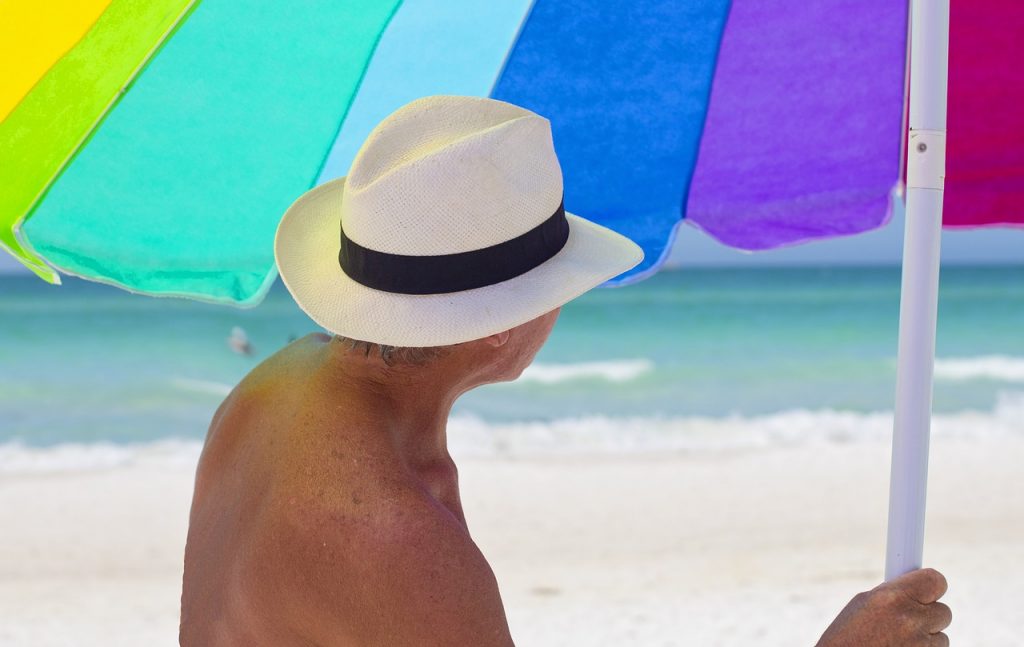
[273,177,643,346]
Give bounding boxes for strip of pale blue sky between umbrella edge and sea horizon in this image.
[0,209,1024,273]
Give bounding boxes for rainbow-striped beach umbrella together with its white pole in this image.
[0,0,1024,576]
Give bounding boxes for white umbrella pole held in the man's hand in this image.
[886,0,949,579]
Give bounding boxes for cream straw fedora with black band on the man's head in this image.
[274,95,643,346]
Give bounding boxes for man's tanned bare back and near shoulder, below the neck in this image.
[180,336,511,646]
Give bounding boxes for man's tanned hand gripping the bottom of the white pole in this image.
[817,568,952,647]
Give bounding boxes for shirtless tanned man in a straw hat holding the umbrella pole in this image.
[180,96,950,647]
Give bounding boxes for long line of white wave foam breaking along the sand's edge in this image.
[0,391,1024,476]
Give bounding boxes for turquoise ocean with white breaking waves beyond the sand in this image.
[0,265,1024,472]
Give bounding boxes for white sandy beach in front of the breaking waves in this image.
[0,438,1024,647]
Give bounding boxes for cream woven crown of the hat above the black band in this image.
[341,95,562,256]
